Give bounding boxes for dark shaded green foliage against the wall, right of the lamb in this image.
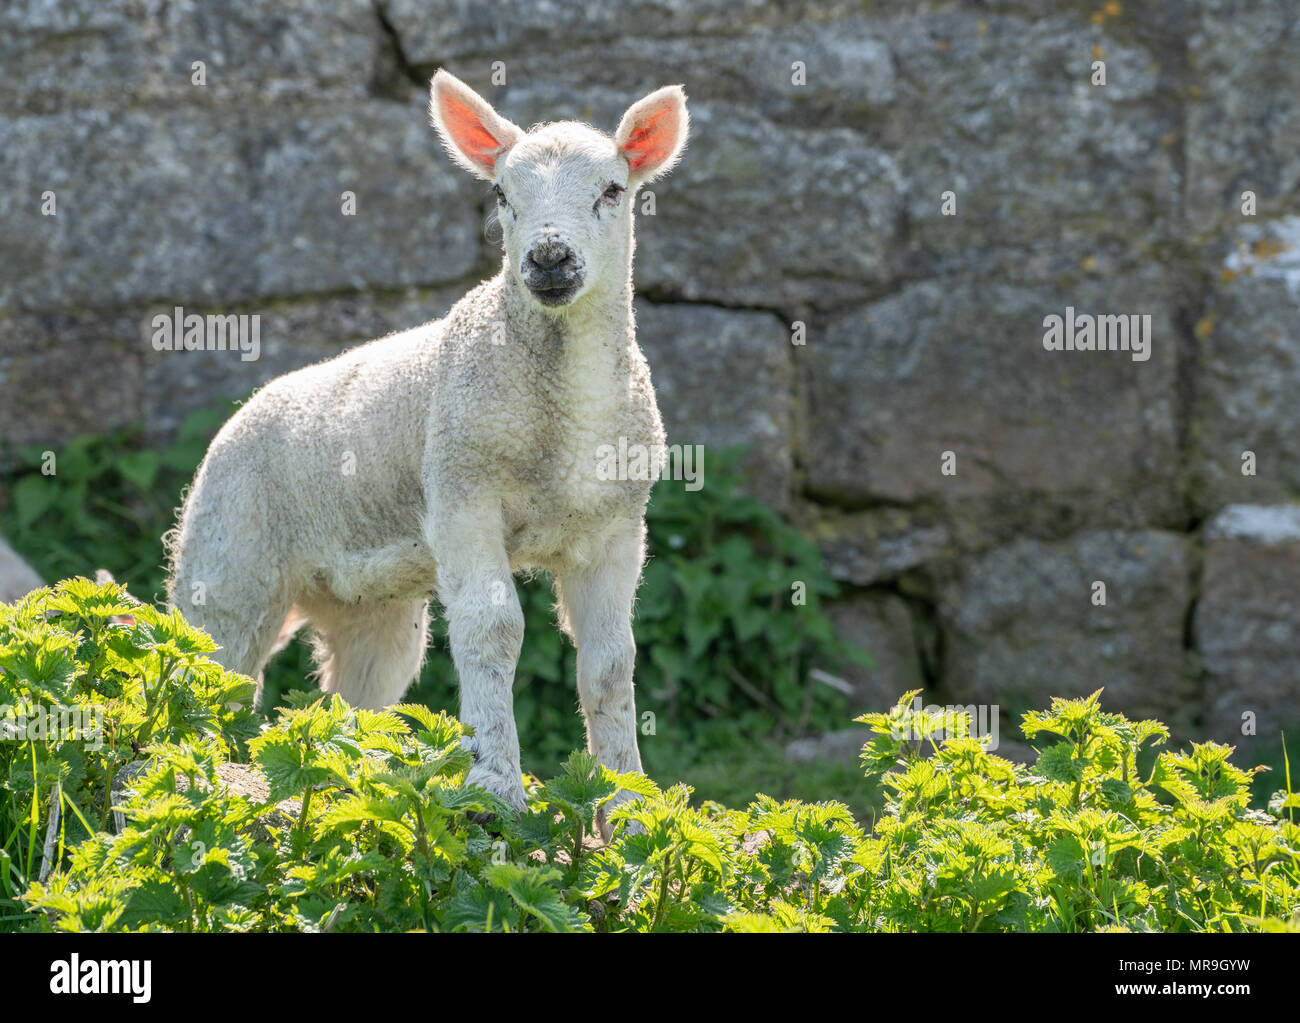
[636,455,870,738]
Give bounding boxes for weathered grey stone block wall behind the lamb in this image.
[0,0,1300,740]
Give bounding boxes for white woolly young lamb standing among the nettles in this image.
[166,70,689,826]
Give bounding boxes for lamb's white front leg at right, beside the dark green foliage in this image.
[559,521,645,841]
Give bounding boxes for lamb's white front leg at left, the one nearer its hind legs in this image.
[432,511,525,810]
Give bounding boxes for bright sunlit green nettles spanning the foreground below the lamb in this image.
[0,580,1300,932]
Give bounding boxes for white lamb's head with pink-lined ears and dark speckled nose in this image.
[429,70,689,311]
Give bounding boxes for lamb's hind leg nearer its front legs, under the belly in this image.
[304,598,429,710]
